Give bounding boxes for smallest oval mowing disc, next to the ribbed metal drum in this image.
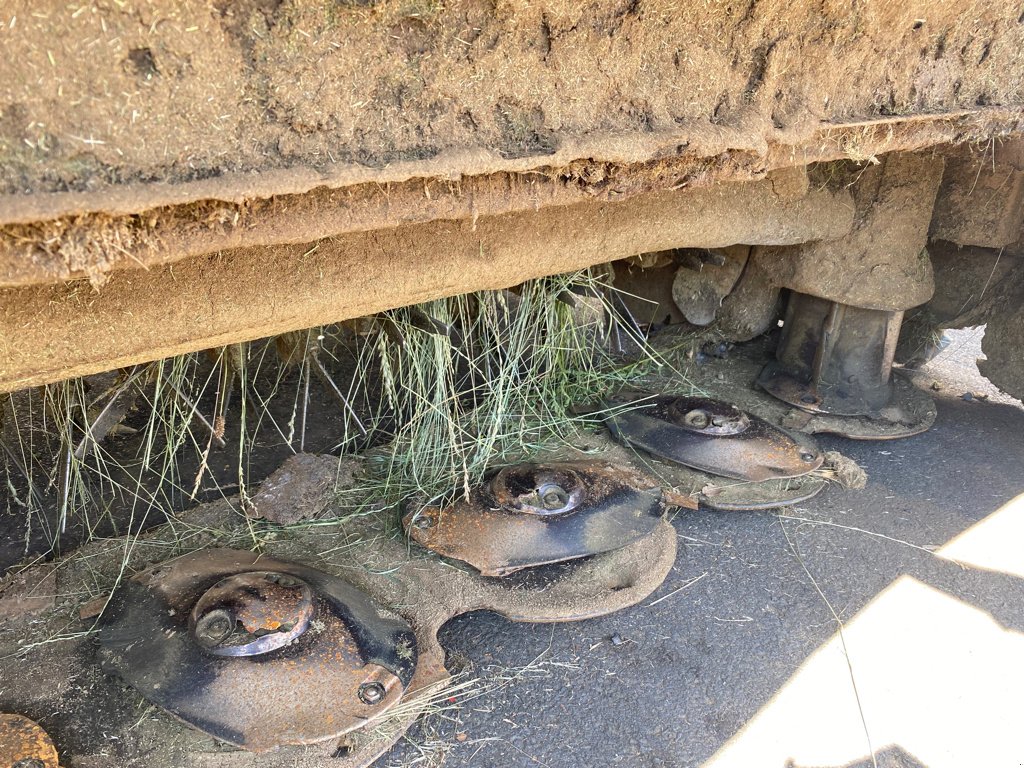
[605,395,823,481]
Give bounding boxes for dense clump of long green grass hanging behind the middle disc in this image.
[360,270,660,499]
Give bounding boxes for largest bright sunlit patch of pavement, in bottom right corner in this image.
[706,577,1024,768]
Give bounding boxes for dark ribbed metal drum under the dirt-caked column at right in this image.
[758,293,903,416]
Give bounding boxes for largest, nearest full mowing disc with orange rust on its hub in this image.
[99,549,417,752]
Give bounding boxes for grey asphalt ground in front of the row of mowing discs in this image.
[377,337,1024,768]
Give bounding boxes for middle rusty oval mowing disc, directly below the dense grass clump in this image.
[402,462,664,577]
